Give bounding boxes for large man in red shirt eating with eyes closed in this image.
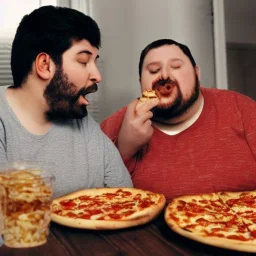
[101,39,256,200]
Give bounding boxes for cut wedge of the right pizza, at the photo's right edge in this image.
[218,191,256,238]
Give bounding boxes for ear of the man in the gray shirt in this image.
[35,52,53,80]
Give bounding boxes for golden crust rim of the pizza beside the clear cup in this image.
[51,188,166,230]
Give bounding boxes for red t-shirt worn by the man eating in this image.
[101,88,256,200]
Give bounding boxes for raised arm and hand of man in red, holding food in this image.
[101,99,158,173]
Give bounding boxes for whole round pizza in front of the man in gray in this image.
[51,188,165,229]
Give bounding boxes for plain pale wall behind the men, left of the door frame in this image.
[91,0,215,119]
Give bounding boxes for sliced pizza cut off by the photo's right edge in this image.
[165,191,256,252]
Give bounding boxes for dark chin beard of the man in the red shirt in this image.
[151,75,200,121]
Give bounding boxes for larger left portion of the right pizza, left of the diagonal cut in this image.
[165,193,256,251]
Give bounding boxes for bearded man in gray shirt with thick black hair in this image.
[0,6,132,197]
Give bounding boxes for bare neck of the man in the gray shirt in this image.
[6,83,51,135]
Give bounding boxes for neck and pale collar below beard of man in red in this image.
[153,91,204,135]
